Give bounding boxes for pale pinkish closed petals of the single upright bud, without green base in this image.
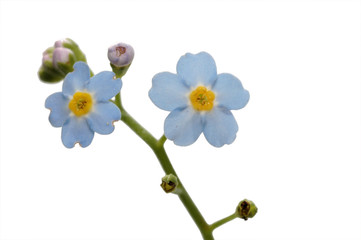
[108,43,134,67]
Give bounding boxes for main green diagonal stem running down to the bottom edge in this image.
[113,93,214,240]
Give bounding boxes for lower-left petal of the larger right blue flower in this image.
[164,107,203,146]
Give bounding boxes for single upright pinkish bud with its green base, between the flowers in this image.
[108,43,134,78]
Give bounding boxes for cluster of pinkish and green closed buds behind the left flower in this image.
[38,38,86,83]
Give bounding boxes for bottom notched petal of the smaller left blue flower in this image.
[61,116,94,148]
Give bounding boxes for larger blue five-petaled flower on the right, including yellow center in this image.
[149,52,249,147]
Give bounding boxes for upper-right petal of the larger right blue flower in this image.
[212,73,249,110]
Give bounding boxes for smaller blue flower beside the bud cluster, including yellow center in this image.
[45,62,122,148]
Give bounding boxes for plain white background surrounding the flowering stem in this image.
[0,0,361,240]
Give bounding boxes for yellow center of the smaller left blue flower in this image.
[69,92,93,117]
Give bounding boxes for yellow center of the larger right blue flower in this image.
[189,86,215,111]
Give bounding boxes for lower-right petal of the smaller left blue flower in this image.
[87,102,120,134]
